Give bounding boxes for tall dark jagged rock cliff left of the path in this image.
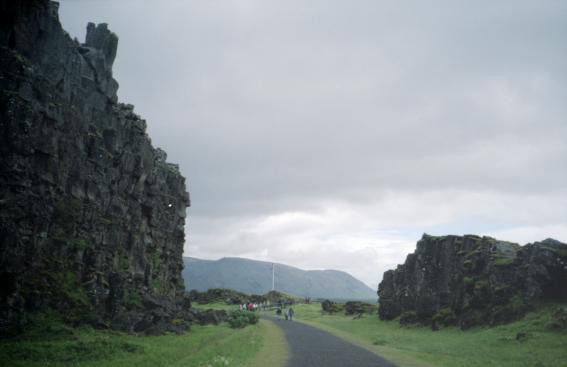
[0,0,189,335]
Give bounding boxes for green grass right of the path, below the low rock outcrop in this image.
[295,304,567,367]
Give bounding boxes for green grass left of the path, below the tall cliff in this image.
[0,317,287,367]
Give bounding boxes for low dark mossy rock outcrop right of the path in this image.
[378,235,567,329]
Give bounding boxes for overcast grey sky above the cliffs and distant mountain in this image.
[60,0,567,288]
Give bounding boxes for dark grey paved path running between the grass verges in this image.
[267,317,396,367]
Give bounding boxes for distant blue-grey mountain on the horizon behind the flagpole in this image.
[183,257,377,300]
